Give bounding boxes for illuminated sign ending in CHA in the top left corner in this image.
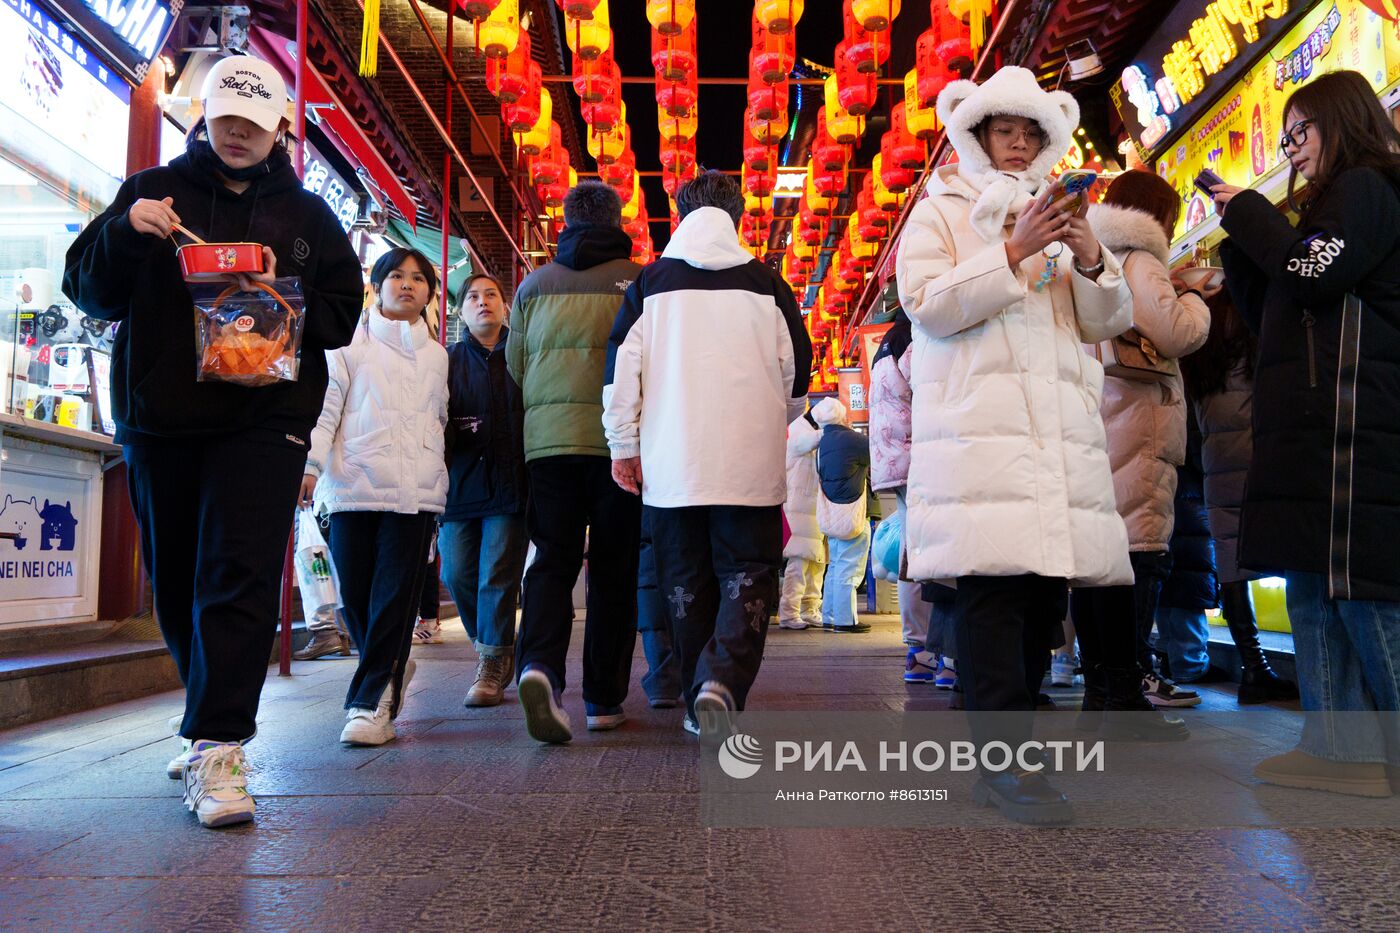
[34,0,185,84]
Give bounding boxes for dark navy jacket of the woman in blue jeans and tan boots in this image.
[442,328,528,521]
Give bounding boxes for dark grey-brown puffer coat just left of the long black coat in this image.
[1193,363,1259,583]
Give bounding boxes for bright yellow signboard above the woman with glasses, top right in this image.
[1156,0,1400,238]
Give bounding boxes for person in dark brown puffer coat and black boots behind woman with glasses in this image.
[1182,291,1298,705]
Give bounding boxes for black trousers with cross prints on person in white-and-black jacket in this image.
[644,506,783,712]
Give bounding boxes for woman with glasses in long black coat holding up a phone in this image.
[1212,71,1400,797]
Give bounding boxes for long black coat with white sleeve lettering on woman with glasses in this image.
[1221,168,1400,601]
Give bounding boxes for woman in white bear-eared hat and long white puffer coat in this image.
[896,67,1133,821]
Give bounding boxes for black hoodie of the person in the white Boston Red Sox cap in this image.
[63,149,364,443]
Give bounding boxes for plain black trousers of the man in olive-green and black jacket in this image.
[515,455,641,706]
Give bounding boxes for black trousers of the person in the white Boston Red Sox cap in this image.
[123,429,307,742]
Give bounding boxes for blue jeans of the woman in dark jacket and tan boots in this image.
[438,514,529,657]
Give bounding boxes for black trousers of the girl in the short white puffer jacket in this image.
[330,511,437,716]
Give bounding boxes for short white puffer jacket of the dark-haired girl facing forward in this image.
[307,308,448,514]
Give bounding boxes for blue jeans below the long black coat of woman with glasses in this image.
[1284,573,1400,765]
